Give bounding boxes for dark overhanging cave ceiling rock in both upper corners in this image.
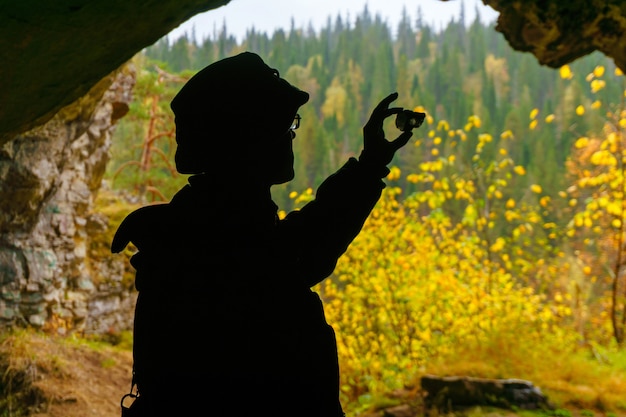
[0,0,626,140]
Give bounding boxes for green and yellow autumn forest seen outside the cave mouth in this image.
[106,7,626,413]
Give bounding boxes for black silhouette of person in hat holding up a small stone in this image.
[111,52,411,417]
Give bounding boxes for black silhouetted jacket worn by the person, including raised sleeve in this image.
[112,158,384,416]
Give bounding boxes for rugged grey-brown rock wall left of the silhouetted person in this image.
[0,65,135,333]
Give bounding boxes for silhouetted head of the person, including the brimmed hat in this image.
[171,52,309,184]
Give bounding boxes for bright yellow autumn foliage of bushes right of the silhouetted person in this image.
[306,65,626,411]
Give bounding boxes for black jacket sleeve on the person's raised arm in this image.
[280,158,389,286]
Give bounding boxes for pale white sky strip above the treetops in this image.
[168,0,498,41]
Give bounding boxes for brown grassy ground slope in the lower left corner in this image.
[0,331,132,417]
